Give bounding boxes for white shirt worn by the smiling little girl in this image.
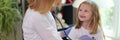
[68,27,104,40]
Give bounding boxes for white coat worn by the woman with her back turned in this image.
[22,8,62,40]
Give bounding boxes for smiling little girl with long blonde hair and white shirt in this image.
[68,0,104,40]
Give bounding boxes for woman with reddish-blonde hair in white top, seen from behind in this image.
[22,0,62,40]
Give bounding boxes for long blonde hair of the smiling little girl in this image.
[75,1,101,34]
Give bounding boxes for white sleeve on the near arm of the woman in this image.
[33,15,62,40]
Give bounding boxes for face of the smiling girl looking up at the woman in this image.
[78,4,92,21]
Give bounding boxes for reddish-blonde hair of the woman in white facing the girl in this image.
[27,0,55,14]
